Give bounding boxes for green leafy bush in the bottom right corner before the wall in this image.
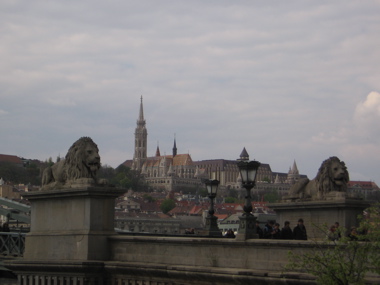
[286,207,380,285]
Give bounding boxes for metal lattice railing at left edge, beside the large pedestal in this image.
[0,232,26,256]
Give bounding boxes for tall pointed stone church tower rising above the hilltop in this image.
[132,96,148,171]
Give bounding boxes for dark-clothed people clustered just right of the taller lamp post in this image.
[256,219,307,240]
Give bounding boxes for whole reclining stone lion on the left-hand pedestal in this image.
[42,137,105,189]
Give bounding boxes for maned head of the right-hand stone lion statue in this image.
[315,156,349,196]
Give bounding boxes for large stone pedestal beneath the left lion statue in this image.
[23,187,125,261]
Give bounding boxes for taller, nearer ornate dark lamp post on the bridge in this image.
[237,148,261,240]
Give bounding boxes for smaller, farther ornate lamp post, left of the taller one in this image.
[204,179,222,236]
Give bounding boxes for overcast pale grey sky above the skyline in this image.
[0,0,380,185]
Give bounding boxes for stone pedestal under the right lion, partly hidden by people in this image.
[268,196,370,239]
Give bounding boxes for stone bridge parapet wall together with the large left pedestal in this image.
[1,187,380,285]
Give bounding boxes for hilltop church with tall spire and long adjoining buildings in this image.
[123,96,306,192]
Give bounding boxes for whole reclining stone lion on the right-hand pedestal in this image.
[286,156,349,200]
